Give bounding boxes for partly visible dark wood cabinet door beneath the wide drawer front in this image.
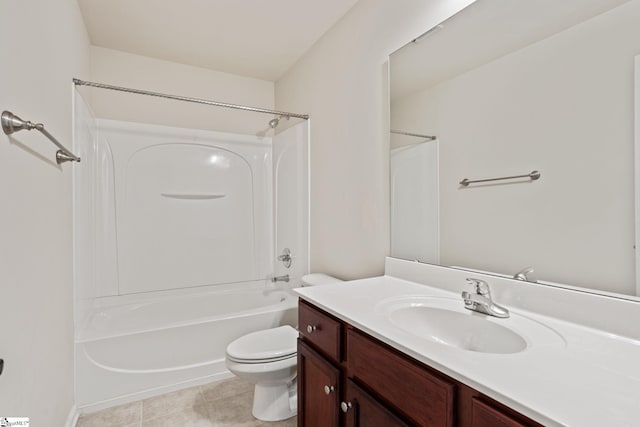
[341,380,409,427]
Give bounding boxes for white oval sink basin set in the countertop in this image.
[377,296,564,354]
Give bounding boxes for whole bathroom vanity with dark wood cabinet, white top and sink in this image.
[296,258,640,427]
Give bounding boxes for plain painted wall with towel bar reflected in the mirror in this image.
[392,0,640,294]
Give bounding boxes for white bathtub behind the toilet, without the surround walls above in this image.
[75,282,297,412]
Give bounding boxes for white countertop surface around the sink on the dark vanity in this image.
[295,276,640,427]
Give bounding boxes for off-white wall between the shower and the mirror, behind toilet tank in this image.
[276,0,473,279]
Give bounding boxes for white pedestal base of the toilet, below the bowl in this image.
[251,378,298,421]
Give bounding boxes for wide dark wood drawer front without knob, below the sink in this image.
[346,328,455,427]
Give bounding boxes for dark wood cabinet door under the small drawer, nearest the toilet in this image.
[298,340,340,427]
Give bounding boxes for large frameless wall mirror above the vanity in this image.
[390,0,640,301]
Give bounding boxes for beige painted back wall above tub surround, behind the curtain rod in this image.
[87,46,274,136]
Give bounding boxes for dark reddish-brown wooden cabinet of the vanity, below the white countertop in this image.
[298,300,541,427]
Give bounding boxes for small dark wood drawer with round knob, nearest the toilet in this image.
[298,300,342,362]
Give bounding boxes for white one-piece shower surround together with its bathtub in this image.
[73,83,308,411]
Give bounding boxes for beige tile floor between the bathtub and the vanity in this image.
[76,378,297,427]
